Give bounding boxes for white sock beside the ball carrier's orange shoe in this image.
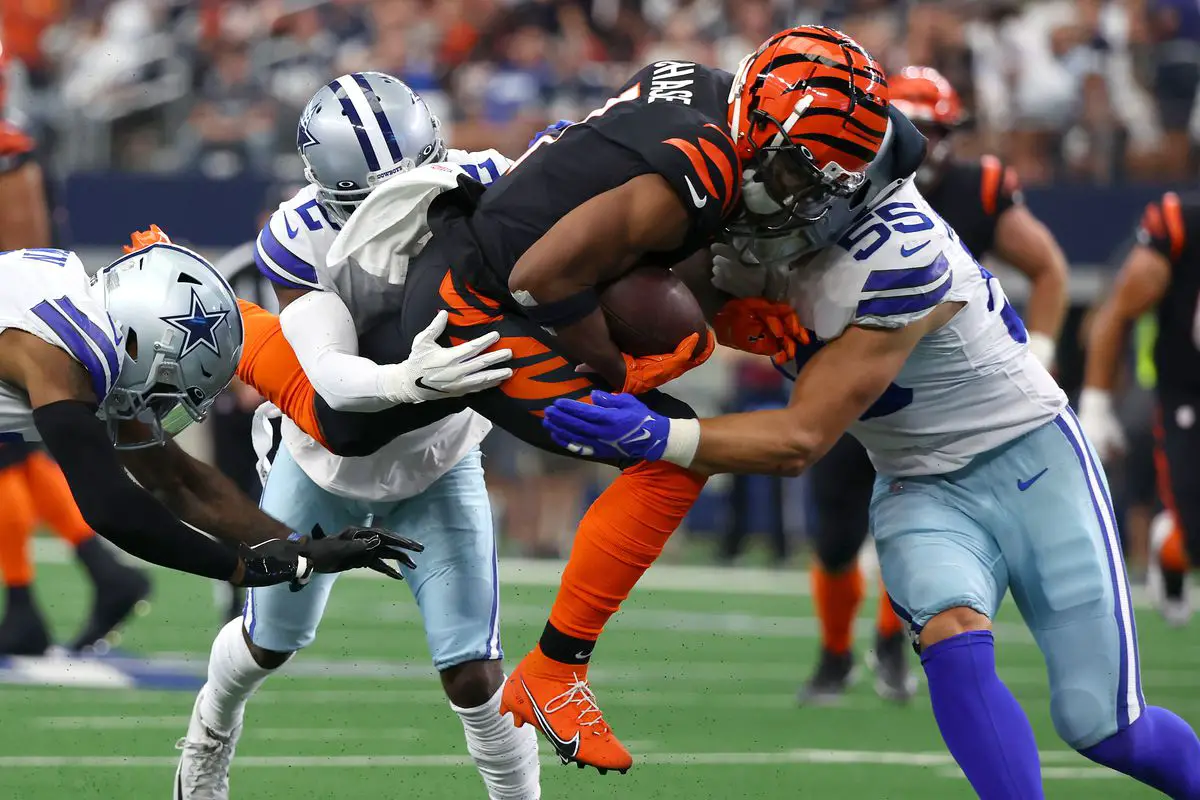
[450,686,541,800]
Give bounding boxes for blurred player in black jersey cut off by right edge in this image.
[1079,192,1200,625]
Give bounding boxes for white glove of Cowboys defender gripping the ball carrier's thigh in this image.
[383,311,512,403]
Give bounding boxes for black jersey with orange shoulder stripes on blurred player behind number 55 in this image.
[920,156,1022,258]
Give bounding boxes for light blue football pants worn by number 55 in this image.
[871,409,1145,750]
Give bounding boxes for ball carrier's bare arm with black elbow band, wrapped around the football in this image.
[509,174,690,389]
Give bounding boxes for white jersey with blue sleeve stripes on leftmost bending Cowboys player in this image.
[0,248,122,441]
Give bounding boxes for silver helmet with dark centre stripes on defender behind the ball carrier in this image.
[296,72,446,223]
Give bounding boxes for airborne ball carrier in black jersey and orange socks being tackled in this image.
[238,26,887,770]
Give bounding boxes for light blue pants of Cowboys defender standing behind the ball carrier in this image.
[242,447,504,670]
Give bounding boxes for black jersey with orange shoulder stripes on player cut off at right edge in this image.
[1138,192,1200,390]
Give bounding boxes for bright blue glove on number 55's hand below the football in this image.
[541,391,671,461]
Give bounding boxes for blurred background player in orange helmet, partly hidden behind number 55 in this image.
[799,67,1067,703]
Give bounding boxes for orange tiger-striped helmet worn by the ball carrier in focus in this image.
[730,25,888,230]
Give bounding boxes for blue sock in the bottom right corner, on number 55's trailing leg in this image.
[1079,705,1200,800]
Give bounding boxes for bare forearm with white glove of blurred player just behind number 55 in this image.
[992,205,1067,367]
